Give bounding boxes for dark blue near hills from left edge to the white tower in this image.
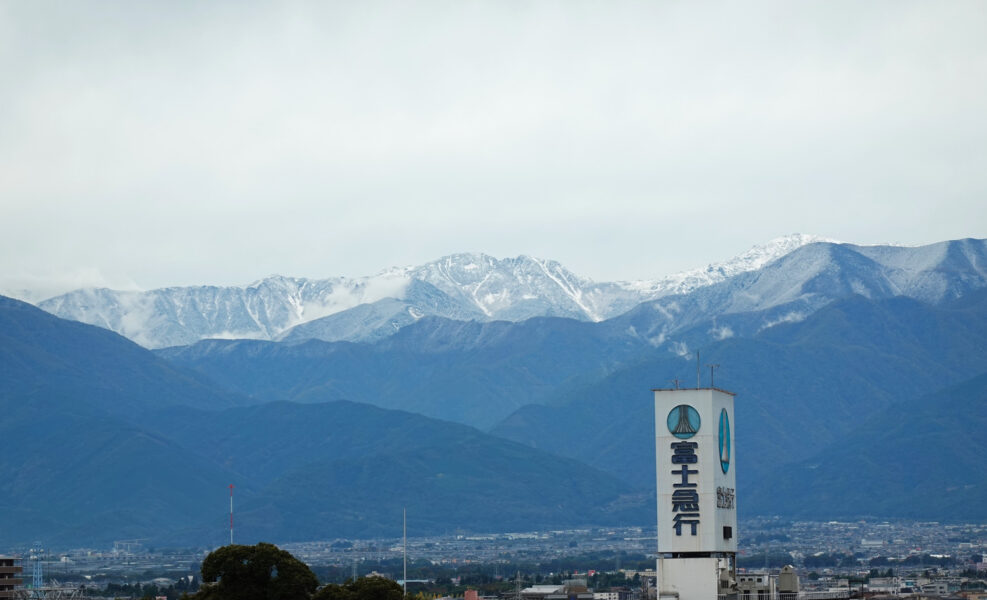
[0,299,651,546]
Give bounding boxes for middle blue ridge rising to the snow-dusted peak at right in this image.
[158,241,987,429]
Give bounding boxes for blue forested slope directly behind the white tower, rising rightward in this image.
[492,291,987,514]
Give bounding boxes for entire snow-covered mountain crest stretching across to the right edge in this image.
[39,234,987,348]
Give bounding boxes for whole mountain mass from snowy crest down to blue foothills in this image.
[0,236,987,544]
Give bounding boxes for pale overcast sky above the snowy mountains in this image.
[0,0,987,295]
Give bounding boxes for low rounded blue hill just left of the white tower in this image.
[141,402,652,540]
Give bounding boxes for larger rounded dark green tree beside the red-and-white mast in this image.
[191,543,319,600]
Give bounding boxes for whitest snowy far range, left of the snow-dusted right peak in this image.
[38,234,823,348]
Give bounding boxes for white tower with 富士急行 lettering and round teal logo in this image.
[654,388,737,600]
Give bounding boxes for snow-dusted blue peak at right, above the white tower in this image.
[607,239,987,356]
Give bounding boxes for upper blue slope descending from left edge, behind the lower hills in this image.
[0,296,242,417]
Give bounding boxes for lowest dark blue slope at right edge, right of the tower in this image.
[744,373,987,522]
